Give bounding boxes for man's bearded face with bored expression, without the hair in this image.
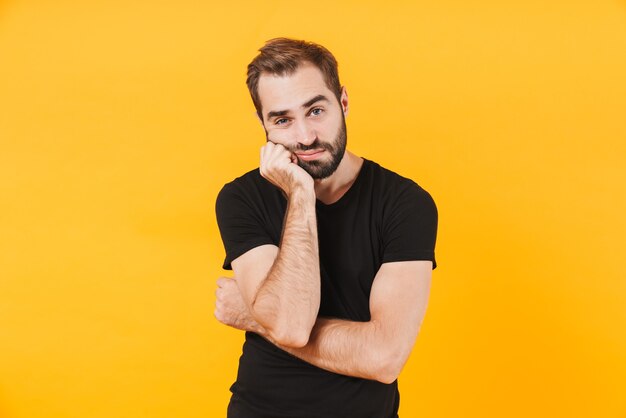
[258,64,348,179]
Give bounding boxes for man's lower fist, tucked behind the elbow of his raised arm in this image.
[214,277,263,333]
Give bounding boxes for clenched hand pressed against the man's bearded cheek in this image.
[260,141,313,196]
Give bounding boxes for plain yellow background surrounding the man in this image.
[0,0,626,418]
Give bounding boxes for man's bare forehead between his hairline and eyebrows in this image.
[258,64,334,115]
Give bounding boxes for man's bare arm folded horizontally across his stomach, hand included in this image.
[216,261,432,383]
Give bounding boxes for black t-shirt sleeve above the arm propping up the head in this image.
[215,183,274,270]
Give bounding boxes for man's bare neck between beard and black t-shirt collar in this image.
[315,150,363,205]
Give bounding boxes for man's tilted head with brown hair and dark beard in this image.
[247,38,348,179]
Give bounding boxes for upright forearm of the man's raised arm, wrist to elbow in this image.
[251,189,320,346]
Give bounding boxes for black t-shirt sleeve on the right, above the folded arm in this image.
[383,183,437,269]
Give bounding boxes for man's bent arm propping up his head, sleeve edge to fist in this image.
[232,142,320,347]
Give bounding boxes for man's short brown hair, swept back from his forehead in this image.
[246,38,341,120]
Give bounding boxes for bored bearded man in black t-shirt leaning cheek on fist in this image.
[215,38,437,418]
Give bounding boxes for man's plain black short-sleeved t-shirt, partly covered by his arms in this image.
[216,160,437,418]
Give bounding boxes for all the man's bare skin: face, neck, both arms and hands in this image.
[215,64,432,383]
